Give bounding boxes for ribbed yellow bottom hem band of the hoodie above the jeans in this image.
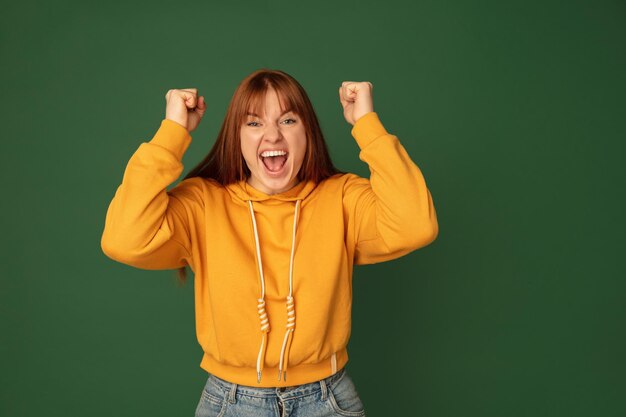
[200,348,348,388]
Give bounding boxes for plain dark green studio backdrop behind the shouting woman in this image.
[0,0,626,417]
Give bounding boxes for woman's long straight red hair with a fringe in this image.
[178,68,345,284]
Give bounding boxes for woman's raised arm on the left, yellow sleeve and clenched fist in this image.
[100,88,206,269]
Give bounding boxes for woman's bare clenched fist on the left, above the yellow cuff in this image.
[165,88,206,132]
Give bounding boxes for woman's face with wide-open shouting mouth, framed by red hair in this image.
[241,88,306,194]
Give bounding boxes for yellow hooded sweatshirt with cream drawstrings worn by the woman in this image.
[101,112,439,387]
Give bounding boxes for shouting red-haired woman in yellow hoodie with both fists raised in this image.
[101,69,438,417]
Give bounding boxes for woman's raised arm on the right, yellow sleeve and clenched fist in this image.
[340,82,439,264]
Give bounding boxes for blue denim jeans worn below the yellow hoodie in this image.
[196,367,365,417]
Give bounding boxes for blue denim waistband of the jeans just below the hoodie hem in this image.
[209,366,346,399]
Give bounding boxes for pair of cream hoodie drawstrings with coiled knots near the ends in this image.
[248,200,301,383]
